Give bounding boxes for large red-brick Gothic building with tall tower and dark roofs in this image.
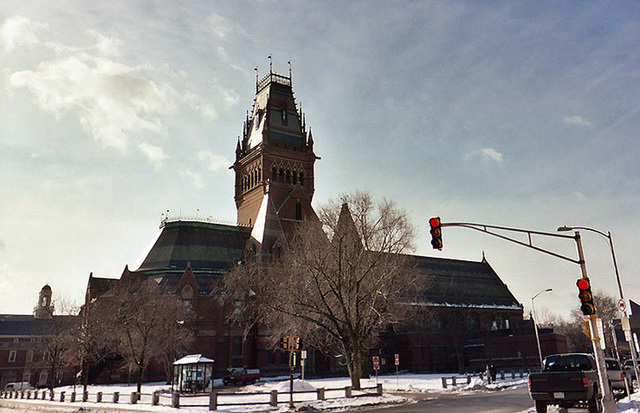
[86,67,536,375]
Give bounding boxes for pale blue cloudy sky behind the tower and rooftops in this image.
[0,0,640,316]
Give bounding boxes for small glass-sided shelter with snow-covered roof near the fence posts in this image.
[171,354,214,393]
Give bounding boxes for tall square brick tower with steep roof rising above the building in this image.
[233,62,319,234]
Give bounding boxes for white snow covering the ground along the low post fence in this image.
[0,374,640,413]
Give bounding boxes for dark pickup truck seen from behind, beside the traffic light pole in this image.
[529,353,600,413]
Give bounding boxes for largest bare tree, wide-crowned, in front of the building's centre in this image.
[226,193,415,389]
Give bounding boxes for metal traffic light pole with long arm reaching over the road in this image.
[432,222,618,413]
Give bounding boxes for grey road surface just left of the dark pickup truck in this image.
[359,386,535,413]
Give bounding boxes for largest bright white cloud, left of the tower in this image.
[10,53,176,151]
